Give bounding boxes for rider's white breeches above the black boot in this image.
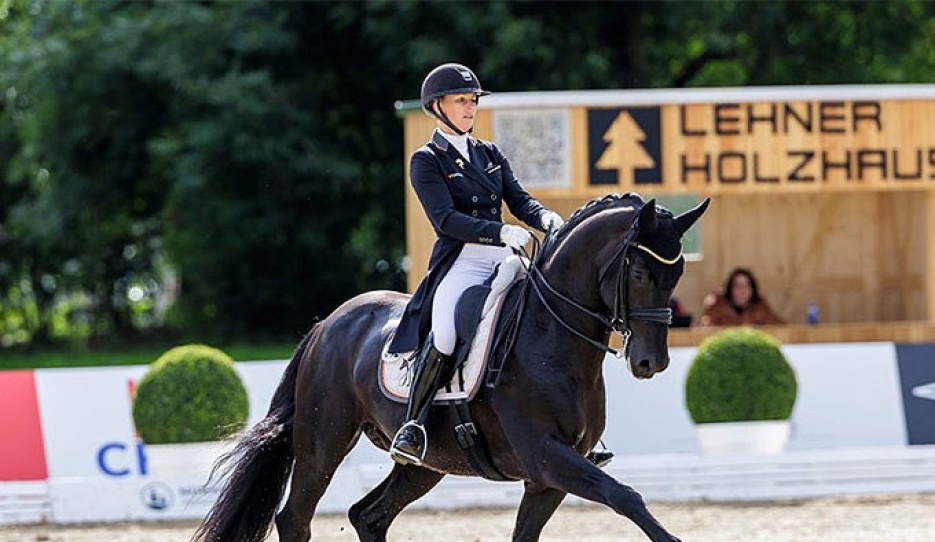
[432,243,513,355]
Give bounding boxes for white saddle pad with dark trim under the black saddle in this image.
[379,256,523,403]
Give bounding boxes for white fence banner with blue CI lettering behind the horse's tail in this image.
[36,361,287,523]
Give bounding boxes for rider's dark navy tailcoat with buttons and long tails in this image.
[389,130,547,353]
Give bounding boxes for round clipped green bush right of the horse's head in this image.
[685,327,798,423]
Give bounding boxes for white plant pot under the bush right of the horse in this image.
[695,420,789,455]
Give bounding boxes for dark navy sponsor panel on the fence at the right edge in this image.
[896,344,935,444]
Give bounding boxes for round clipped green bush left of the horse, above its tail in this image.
[133,344,249,444]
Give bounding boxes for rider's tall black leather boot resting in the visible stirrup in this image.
[390,344,451,465]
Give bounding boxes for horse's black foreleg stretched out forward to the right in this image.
[530,441,680,542]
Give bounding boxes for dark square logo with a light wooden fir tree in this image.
[588,107,662,185]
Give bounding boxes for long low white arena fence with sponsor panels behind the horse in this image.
[0,343,935,524]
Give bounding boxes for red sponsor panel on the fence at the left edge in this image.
[0,371,47,482]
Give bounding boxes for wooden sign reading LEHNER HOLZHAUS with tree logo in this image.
[587,100,935,193]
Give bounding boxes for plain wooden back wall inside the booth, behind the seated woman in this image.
[677,192,928,323]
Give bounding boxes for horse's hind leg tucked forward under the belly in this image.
[347,464,445,542]
